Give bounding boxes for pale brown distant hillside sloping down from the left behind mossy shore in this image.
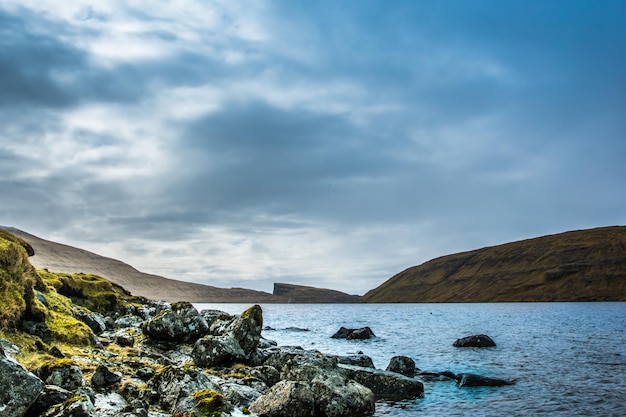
[1,227,357,303]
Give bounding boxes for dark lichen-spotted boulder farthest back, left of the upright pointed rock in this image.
[142,301,209,343]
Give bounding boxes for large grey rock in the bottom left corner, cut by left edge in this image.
[0,345,43,417]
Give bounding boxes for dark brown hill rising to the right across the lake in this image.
[359,226,626,303]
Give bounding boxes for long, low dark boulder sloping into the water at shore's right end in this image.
[340,365,424,401]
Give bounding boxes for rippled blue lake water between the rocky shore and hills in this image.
[196,303,626,417]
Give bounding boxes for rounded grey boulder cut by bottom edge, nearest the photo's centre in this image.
[249,381,316,417]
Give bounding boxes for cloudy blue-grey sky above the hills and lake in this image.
[0,0,626,294]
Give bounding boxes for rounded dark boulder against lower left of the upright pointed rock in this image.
[191,335,246,368]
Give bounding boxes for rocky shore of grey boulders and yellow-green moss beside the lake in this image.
[0,229,511,417]
